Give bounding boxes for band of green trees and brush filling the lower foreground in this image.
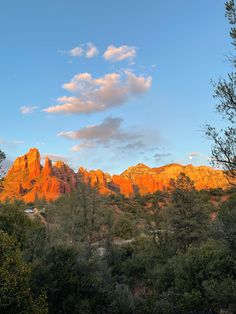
[0,174,236,314]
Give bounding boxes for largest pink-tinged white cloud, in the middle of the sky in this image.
[43,70,152,114]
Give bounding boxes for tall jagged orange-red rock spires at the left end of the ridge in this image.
[0,148,76,202]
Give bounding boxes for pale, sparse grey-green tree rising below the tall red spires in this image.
[46,182,105,259]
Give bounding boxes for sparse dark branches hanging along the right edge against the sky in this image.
[205,0,236,184]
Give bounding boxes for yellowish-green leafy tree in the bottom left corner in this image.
[0,231,47,314]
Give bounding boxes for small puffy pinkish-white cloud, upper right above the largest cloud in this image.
[103,45,137,62]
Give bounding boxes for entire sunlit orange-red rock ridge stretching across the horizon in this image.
[0,148,232,202]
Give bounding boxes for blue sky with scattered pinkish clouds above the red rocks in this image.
[0,0,231,173]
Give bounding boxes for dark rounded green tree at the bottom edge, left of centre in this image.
[32,245,108,314]
